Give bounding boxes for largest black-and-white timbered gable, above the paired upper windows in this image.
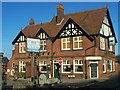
[54,18,93,41]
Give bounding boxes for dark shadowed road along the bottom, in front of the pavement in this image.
[3,75,120,90]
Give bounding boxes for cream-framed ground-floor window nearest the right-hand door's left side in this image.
[73,60,83,73]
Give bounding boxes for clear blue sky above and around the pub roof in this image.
[0,2,118,58]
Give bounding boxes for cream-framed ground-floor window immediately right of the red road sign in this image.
[62,60,71,73]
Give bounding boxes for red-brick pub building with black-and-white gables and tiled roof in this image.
[7,3,117,79]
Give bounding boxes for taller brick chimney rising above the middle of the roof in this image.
[57,3,64,24]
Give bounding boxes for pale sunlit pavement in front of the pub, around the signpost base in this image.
[3,78,109,90]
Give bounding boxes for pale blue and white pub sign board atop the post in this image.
[27,38,40,52]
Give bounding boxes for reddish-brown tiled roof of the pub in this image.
[23,7,107,37]
